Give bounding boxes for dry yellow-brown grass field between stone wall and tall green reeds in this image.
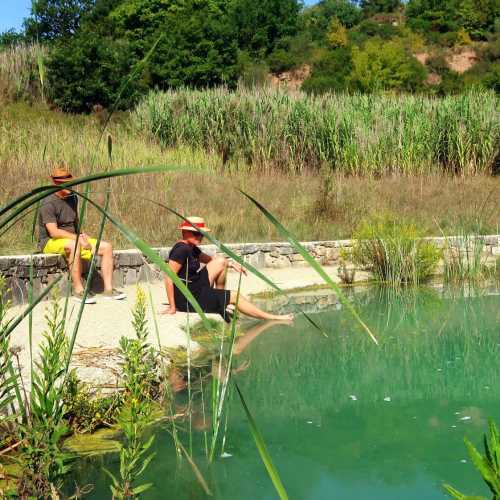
[0,105,500,253]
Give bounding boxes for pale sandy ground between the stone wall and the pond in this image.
[6,267,362,387]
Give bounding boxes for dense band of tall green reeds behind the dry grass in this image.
[133,88,500,175]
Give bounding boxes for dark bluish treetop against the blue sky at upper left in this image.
[24,0,95,41]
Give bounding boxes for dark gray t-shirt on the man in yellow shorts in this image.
[38,193,78,252]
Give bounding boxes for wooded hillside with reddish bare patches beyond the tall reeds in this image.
[0,0,500,112]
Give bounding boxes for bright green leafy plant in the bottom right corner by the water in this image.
[444,420,500,500]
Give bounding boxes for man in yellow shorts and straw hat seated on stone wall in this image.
[38,166,126,304]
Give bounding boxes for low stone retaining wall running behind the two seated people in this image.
[0,235,500,303]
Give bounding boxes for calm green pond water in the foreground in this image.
[71,288,500,500]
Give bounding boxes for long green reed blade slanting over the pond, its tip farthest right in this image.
[239,189,378,345]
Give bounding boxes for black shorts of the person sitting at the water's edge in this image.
[174,267,231,322]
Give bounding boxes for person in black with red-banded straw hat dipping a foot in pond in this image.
[164,217,293,322]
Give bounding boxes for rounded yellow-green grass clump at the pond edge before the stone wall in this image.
[351,216,441,286]
